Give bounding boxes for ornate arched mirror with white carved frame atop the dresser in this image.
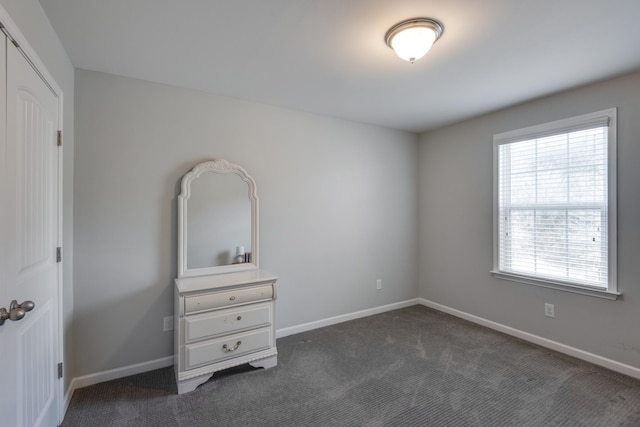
[178,159,258,277]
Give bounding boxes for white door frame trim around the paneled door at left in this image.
[0,5,68,424]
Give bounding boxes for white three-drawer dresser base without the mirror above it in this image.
[174,269,278,394]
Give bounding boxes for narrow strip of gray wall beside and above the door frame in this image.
[0,0,74,390]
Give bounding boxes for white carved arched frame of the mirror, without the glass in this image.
[178,159,258,278]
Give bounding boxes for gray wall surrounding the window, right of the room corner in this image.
[418,74,640,368]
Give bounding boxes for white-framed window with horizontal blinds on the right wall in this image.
[492,108,618,299]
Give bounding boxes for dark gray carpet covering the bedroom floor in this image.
[62,306,640,427]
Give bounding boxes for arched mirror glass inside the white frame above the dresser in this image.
[187,172,251,269]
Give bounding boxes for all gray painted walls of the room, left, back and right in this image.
[16,0,640,389]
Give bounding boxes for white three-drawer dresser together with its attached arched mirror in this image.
[174,159,278,394]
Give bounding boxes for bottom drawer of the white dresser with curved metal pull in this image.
[185,328,272,369]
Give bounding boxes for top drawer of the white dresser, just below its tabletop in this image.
[184,283,275,314]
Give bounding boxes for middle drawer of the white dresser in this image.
[184,302,273,342]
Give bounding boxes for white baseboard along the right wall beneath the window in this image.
[418,298,640,379]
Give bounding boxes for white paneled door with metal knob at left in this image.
[0,32,61,427]
